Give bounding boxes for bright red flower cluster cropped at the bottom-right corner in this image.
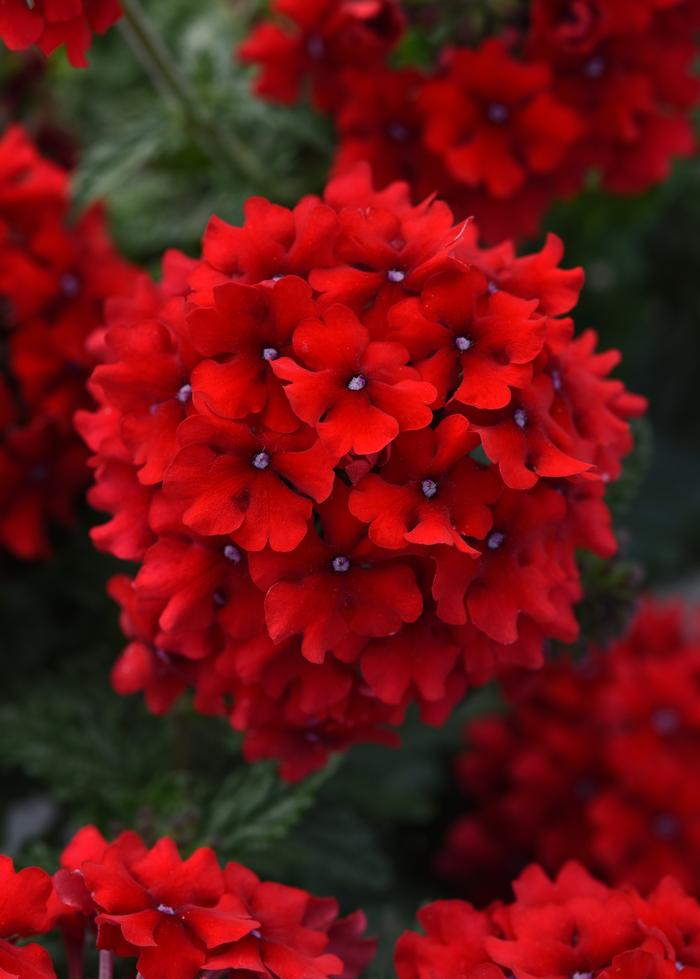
[395,863,700,979]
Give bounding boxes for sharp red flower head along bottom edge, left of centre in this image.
[55,826,374,979]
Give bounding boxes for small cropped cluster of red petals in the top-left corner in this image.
[0,0,122,68]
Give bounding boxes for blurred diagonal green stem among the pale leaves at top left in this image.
[121,0,266,188]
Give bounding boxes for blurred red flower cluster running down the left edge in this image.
[0,126,133,558]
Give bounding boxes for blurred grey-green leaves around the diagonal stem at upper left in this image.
[47,0,331,263]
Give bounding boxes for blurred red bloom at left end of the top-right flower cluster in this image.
[238,0,404,110]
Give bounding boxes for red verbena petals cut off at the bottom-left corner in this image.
[0,855,56,979]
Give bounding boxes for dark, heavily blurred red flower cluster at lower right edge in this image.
[439,605,700,897]
